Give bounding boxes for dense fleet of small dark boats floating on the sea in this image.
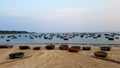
[0,33,120,41]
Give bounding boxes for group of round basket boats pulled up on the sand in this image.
[0,44,111,59]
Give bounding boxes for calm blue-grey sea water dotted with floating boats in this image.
[0,33,120,45]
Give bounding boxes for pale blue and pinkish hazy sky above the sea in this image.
[0,0,120,32]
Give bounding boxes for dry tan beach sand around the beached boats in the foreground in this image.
[0,46,120,68]
